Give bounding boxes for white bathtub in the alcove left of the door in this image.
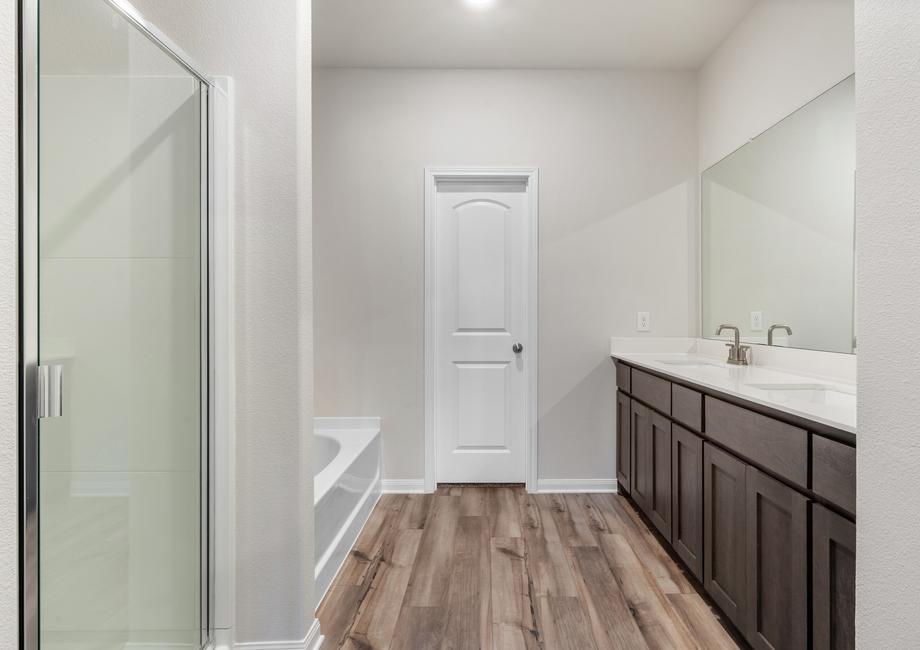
[313,418,380,608]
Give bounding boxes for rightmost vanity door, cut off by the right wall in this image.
[811,504,856,650]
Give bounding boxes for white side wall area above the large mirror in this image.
[699,0,853,170]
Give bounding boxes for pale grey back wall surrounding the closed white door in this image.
[314,69,697,479]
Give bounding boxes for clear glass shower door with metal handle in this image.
[24,0,207,650]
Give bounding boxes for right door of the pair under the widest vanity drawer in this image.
[745,466,808,650]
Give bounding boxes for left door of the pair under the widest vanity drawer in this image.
[703,443,748,629]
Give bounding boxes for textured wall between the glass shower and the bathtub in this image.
[102,0,313,642]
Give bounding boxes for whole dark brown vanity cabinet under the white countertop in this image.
[617,363,856,650]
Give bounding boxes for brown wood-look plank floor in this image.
[317,487,738,650]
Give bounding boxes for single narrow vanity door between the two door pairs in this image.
[671,424,703,580]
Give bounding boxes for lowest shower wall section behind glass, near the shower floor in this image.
[41,472,199,640]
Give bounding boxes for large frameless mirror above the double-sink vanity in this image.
[701,76,856,353]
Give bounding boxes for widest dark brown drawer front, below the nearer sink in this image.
[706,396,808,488]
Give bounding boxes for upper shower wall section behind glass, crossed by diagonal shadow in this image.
[40,76,200,257]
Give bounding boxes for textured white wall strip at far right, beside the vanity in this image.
[856,0,920,648]
